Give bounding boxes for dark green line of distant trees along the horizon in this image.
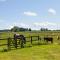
[0,26,60,32]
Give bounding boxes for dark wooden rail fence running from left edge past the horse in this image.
[0,36,41,50]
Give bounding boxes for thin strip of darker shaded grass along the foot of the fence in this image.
[0,43,53,52]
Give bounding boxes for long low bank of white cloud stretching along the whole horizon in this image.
[0,21,60,30]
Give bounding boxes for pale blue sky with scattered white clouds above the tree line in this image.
[0,0,60,30]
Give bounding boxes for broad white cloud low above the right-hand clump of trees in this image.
[33,22,57,30]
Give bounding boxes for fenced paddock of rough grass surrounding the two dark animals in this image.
[0,32,60,50]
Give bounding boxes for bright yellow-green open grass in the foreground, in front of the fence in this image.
[0,44,60,60]
